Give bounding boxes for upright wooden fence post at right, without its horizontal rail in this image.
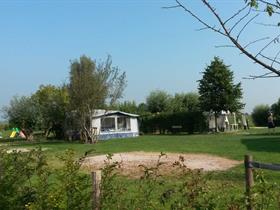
[244,155,254,210]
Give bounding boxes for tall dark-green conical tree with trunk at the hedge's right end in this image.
[198,57,244,129]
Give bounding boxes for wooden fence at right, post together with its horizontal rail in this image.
[244,155,280,210]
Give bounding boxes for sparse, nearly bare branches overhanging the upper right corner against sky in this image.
[164,0,280,79]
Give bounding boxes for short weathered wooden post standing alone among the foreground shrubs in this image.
[91,170,101,210]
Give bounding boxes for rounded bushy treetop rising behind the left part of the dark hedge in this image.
[146,90,171,113]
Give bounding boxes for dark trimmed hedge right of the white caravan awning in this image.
[140,111,206,134]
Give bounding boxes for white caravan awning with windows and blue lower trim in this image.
[92,109,139,140]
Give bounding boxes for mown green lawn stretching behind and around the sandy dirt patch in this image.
[3,128,280,181]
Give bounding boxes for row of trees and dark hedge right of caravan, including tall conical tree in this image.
[116,57,244,133]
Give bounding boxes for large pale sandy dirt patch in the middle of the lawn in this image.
[83,152,241,176]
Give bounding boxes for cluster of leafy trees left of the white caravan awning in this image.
[3,56,126,142]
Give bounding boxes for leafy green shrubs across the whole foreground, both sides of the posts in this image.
[0,148,280,210]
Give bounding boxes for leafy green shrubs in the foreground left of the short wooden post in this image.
[0,148,91,210]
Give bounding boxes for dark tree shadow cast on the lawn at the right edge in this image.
[241,135,280,153]
